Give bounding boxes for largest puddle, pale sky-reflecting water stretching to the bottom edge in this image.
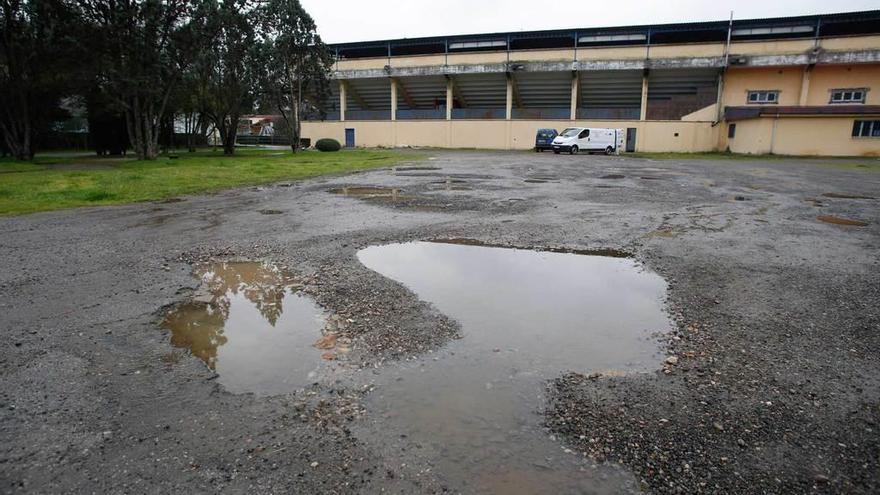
[358,242,671,494]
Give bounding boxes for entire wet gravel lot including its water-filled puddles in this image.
[0,152,880,493]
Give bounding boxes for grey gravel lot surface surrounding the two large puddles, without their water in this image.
[0,152,880,493]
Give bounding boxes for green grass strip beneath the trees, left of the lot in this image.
[0,150,423,215]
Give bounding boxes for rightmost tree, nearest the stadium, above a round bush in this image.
[260,0,333,153]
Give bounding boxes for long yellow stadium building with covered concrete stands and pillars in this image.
[302,11,880,156]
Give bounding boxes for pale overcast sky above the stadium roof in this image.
[300,0,880,43]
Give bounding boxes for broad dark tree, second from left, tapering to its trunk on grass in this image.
[75,0,203,160]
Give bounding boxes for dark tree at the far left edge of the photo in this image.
[0,0,74,160]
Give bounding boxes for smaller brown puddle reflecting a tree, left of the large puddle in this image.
[162,262,325,395]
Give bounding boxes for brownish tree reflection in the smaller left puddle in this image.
[163,263,300,369]
